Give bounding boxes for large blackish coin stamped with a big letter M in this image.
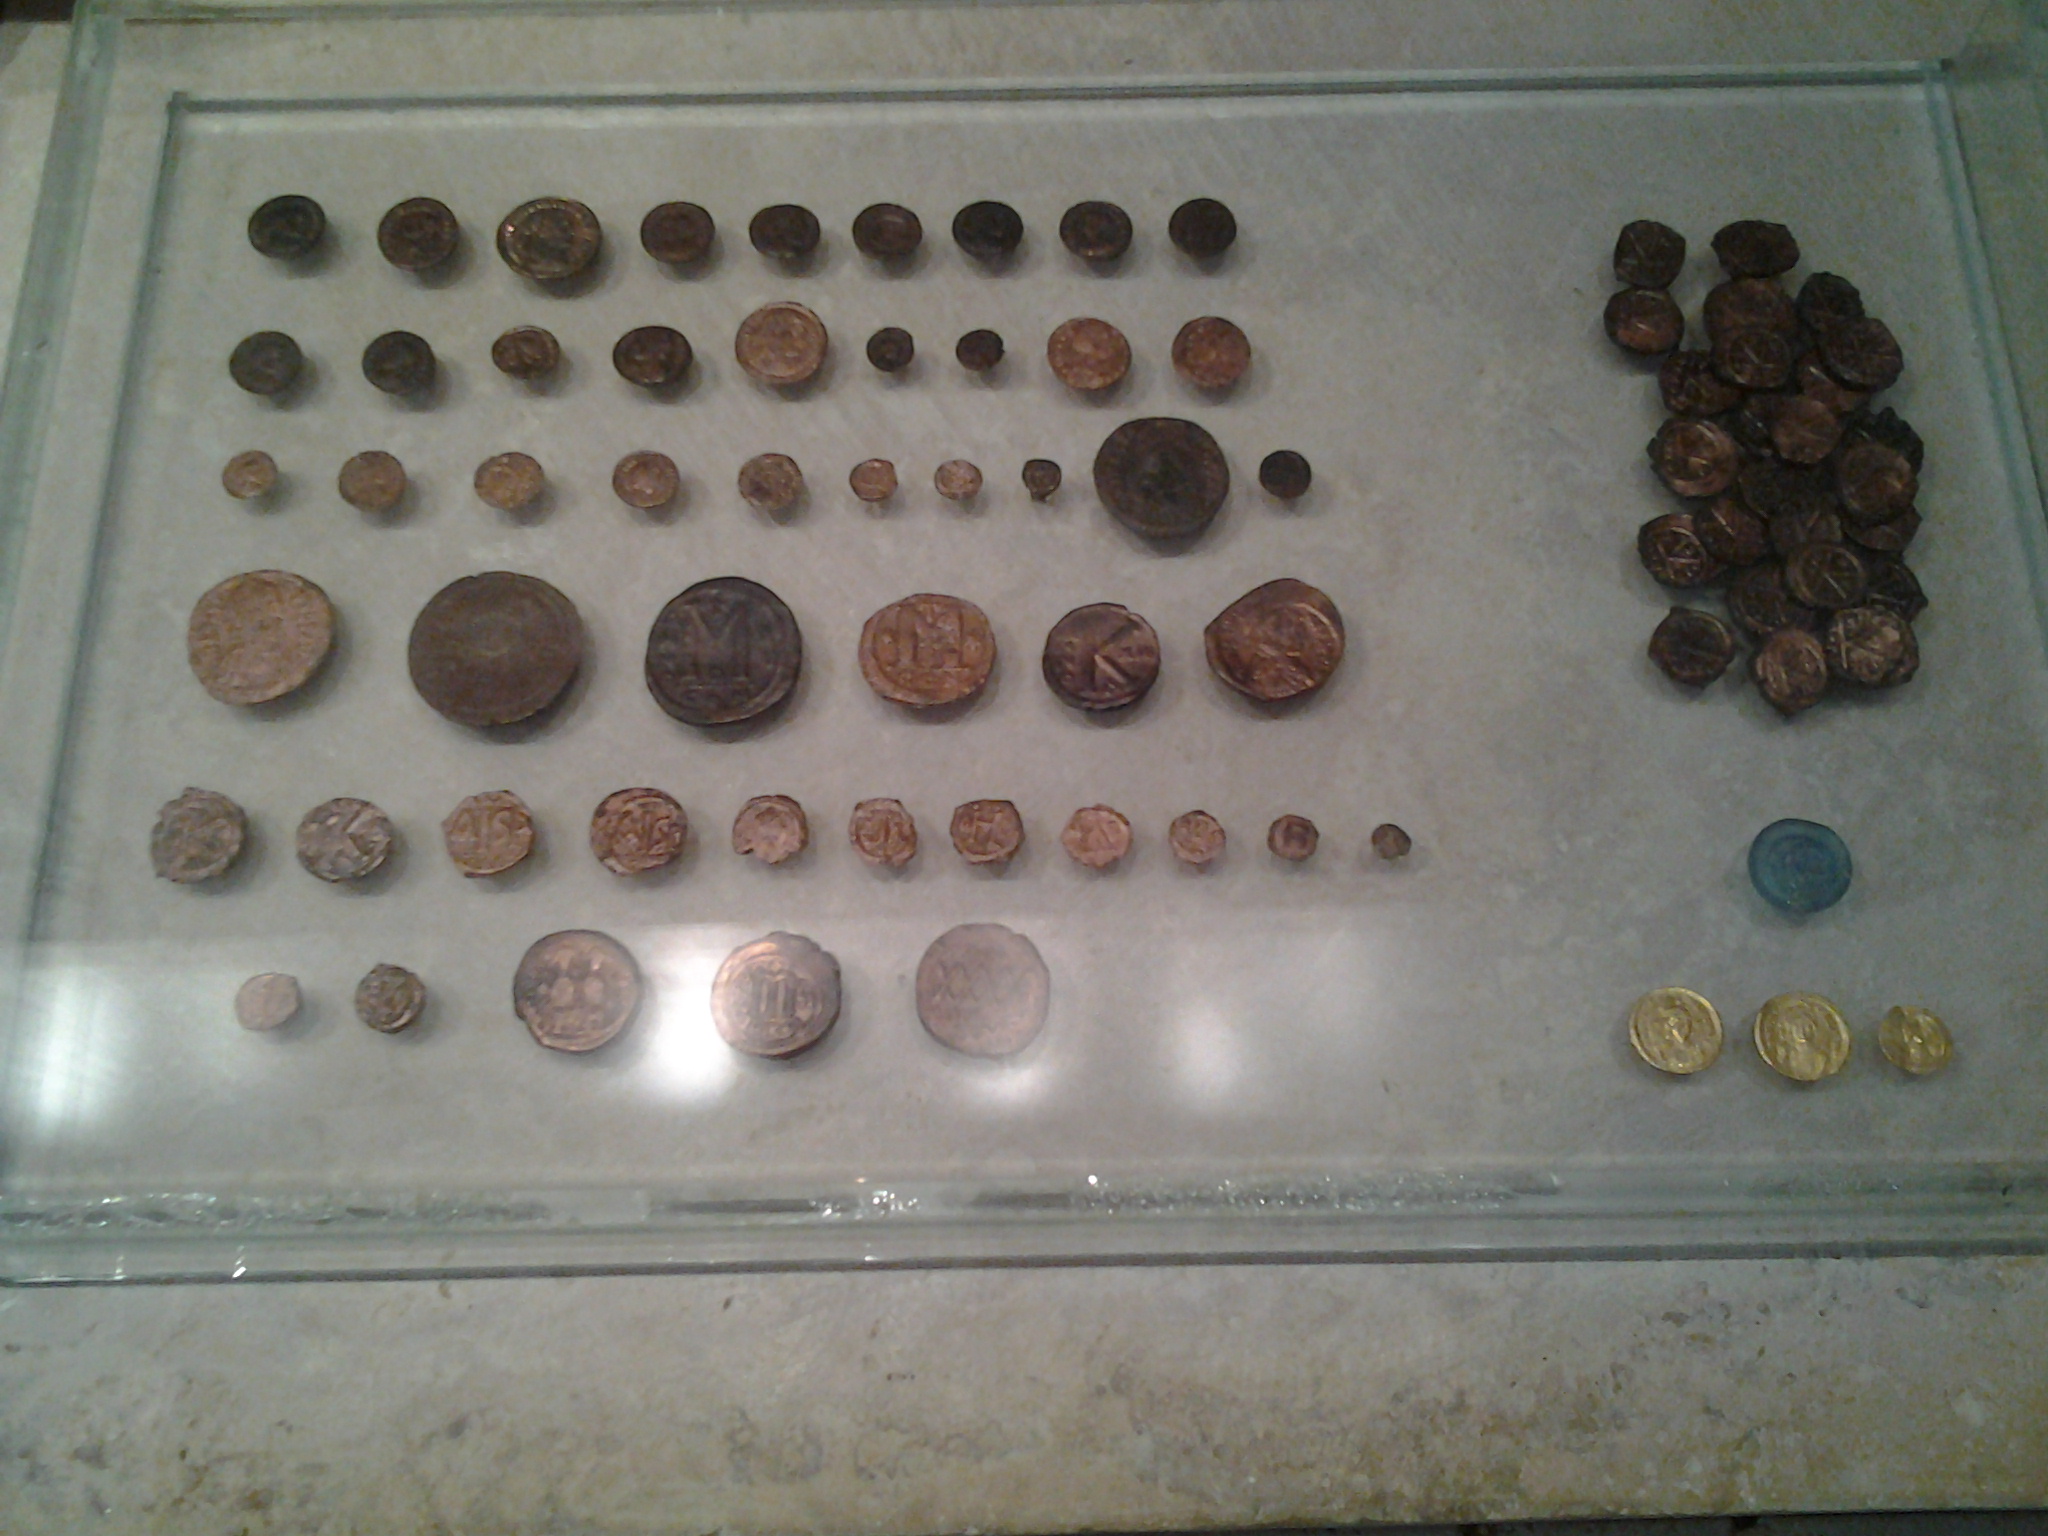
[647,575,803,725]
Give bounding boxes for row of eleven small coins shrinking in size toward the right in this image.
[150,786,1413,885]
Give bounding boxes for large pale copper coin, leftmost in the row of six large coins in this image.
[184,571,334,705]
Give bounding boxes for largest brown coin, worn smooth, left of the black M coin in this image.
[406,571,584,725]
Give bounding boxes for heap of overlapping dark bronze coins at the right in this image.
[1606,219,1927,717]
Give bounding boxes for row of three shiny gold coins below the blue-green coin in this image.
[1628,987,1954,1083]
